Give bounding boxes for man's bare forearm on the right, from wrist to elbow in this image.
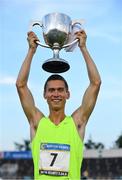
[80,46,101,84]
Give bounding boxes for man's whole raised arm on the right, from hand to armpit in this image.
[72,30,101,138]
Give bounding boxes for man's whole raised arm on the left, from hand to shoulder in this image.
[16,32,43,127]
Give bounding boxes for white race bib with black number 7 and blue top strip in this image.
[39,143,70,176]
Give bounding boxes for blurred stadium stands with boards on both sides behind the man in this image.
[0,148,122,180]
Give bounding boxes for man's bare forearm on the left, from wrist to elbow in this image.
[16,48,34,87]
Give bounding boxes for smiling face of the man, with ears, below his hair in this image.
[44,80,70,110]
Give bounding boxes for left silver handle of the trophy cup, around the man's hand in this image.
[29,21,50,48]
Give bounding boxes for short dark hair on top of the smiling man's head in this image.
[44,74,69,92]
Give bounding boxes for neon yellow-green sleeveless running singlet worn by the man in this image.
[32,116,83,180]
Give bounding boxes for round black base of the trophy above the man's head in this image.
[42,58,70,73]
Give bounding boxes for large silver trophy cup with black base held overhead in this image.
[31,13,82,73]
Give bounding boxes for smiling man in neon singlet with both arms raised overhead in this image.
[16,13,101,180]
